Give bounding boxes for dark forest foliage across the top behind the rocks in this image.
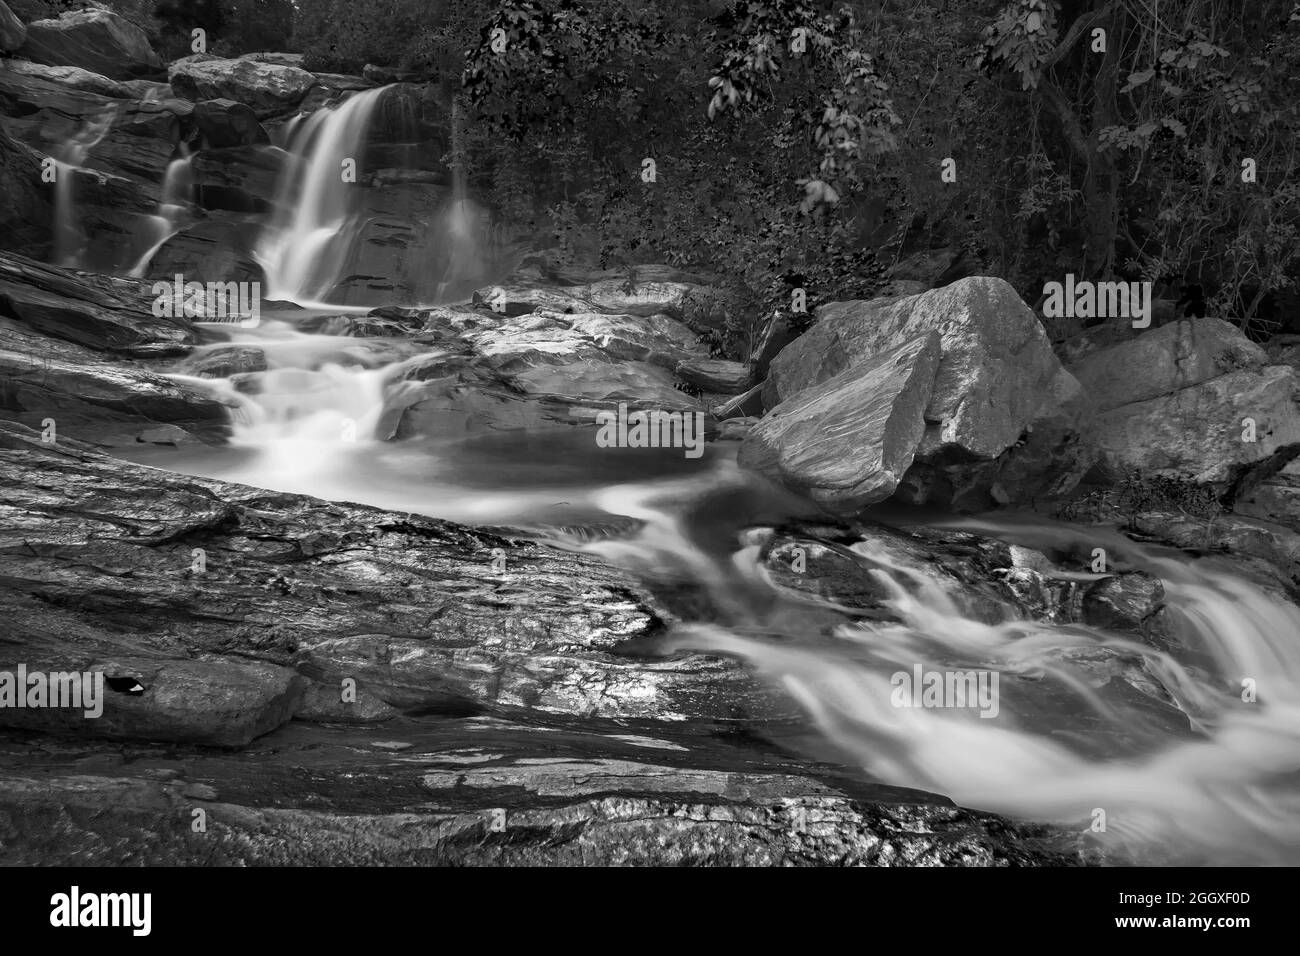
[10,0,1300,345]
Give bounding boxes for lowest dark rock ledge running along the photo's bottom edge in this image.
[0,718,1101,866]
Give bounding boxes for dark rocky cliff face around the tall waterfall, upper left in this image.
[0,38,478,295]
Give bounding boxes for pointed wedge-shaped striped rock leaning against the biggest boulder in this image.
[738,330,941,512]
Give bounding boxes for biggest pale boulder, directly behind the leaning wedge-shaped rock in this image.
[755,277,1095,511]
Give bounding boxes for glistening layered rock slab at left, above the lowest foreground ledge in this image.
[0,423,774,732]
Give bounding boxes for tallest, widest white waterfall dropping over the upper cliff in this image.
[254,87,386,303]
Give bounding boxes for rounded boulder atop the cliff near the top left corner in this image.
[18,9,161,79]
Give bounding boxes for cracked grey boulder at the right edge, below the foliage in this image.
[1074,319,1300,488]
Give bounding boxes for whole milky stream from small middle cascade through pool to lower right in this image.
[124,313,1300,862]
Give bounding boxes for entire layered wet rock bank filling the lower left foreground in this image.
[0,424,1123,865]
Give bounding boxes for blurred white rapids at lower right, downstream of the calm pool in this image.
[585,486,1300,864]
